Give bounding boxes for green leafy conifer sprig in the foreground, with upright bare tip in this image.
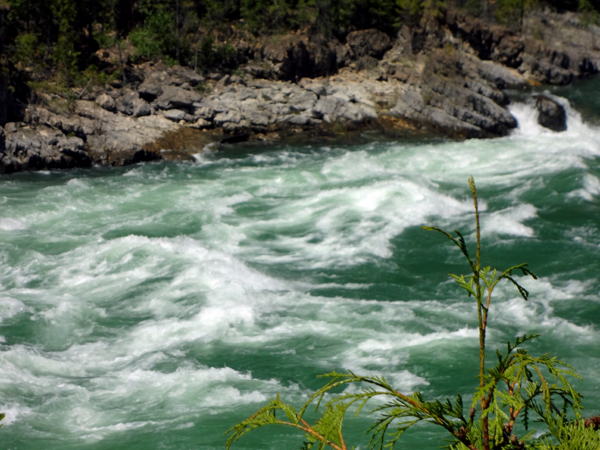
[226,177,600,450]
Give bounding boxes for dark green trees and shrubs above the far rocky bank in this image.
[0,0,600,84]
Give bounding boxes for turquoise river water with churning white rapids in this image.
[0,88,600,450]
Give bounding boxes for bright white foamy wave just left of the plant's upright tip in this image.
[237,179,470,269]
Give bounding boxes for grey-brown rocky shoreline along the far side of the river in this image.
[0,10,600,173]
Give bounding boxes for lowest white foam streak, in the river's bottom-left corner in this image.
[0,340,282,440]
